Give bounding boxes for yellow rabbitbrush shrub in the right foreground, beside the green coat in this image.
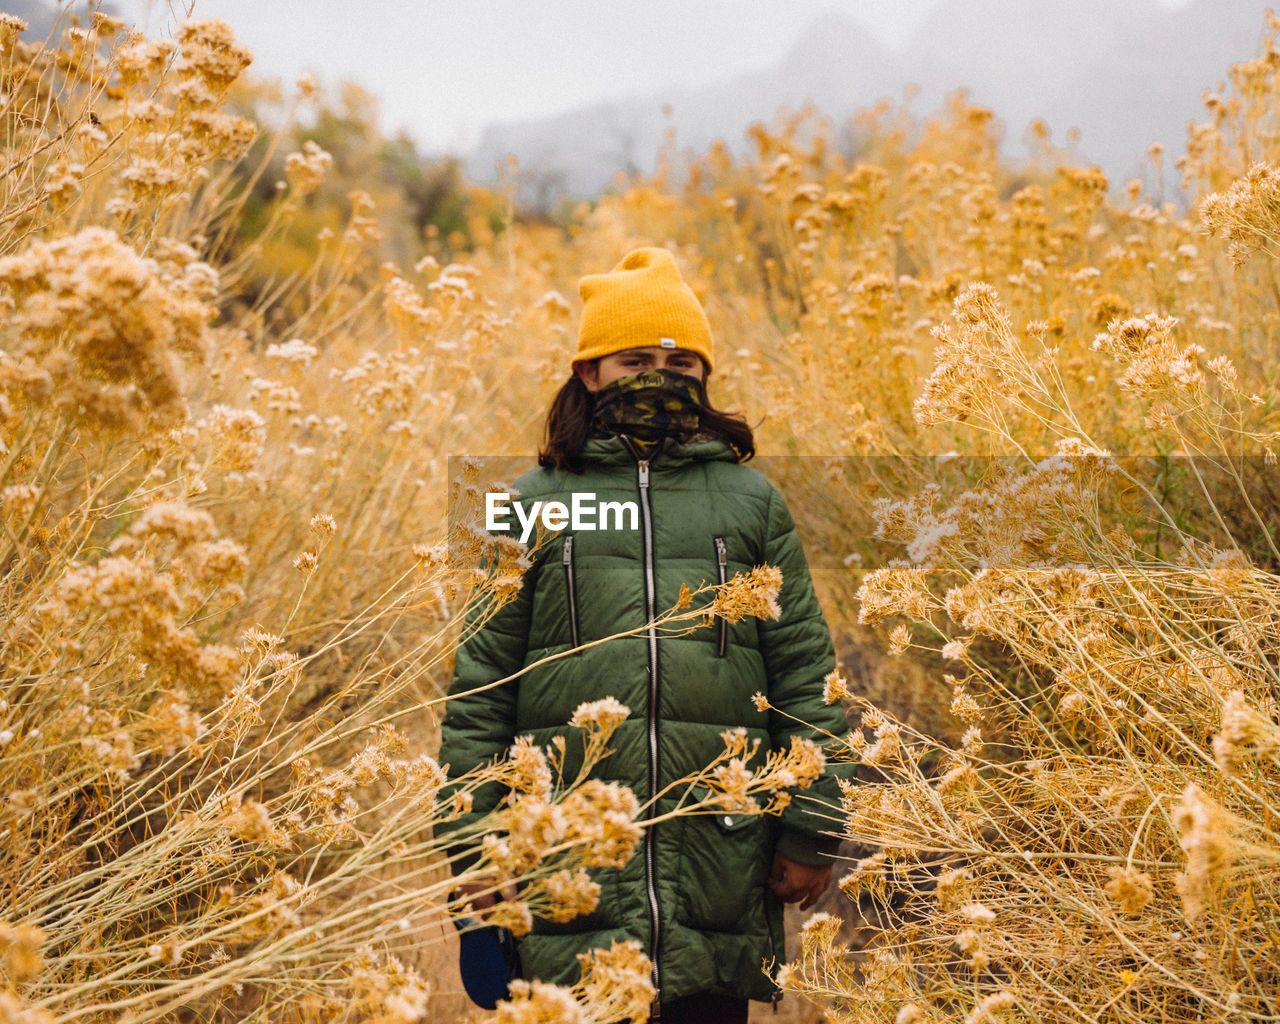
[791,435,1280,1020]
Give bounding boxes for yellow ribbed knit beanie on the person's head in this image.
[573,248,712,369]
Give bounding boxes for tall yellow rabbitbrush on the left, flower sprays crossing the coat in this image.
[0,15,721,1023]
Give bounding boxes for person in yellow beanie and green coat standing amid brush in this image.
[440,248,846,1024]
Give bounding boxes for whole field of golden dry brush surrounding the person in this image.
[0,2,1280,1023]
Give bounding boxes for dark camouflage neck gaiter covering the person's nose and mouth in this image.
[591,369,701,454]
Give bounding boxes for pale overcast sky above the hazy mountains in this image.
[115,0,1187,151]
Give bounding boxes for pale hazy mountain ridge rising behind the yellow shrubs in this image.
[468,0,1266,202]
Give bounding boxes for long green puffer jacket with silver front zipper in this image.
[440,438,846,1001]
